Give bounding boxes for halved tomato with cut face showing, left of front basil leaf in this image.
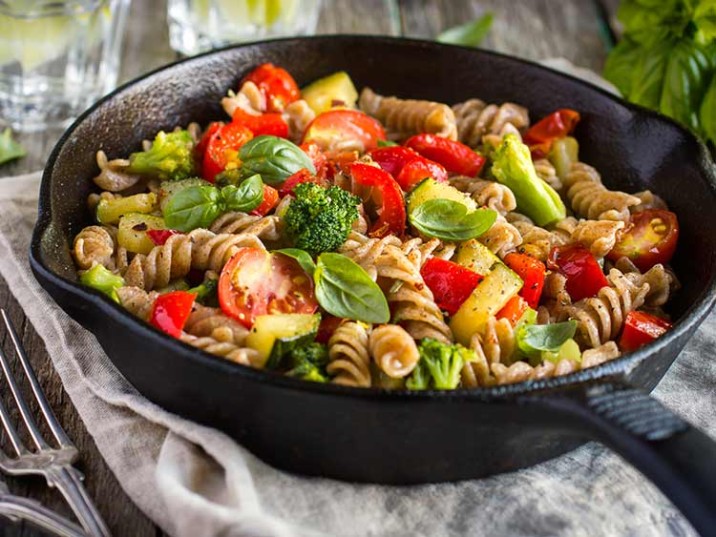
[219,247,318,328]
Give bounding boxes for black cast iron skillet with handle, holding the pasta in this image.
[30,36,716,534]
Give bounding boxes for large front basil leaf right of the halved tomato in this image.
[313,252,390,323]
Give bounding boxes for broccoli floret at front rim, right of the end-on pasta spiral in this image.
[405,338,474,390]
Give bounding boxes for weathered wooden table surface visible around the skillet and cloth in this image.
[0,0,618,537]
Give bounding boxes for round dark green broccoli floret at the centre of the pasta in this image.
[284,183,360,255]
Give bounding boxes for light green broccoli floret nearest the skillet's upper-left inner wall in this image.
[127,130,195,181]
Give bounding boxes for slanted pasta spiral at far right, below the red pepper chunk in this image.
[565,269,649,348]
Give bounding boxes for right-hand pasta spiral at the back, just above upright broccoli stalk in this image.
[452,99,530,147]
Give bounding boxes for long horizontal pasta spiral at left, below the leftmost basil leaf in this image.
[124,229,264,290]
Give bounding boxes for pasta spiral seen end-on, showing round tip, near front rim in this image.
[368,324,420,378]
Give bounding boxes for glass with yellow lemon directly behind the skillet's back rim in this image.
[167,0,321,56]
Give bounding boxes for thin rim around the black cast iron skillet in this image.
[29,34,716,402]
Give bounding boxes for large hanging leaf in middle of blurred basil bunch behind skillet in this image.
[659,39,710,132]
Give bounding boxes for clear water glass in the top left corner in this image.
[0,0,130,132]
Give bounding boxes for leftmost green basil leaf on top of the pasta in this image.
[163,186,222,231]
